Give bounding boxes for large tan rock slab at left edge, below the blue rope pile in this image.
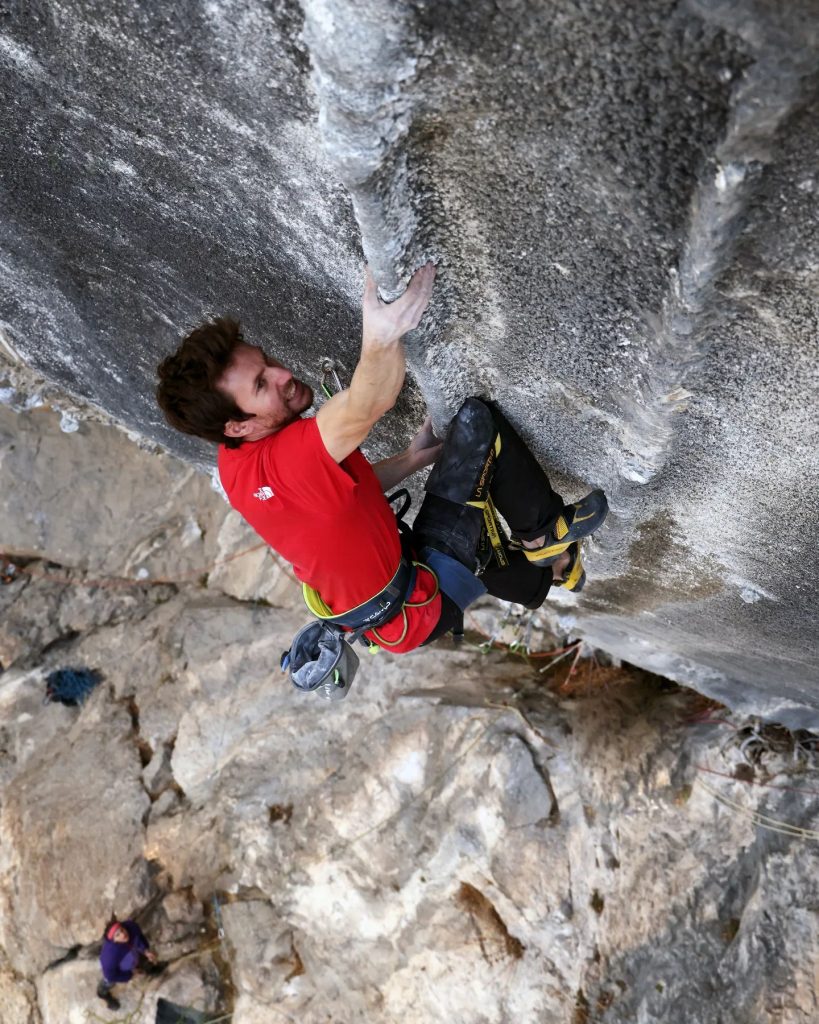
[0,694,149,974]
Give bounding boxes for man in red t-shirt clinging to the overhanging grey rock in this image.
[157,263,608,688]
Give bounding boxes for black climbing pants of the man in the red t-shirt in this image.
[413,398,563,643]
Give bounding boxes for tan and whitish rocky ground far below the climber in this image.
[0,397,819,1024]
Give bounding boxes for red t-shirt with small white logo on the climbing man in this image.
[219,419,441,653]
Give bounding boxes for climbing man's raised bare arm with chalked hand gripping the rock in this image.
[315,263,435,462]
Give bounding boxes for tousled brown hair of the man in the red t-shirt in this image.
[157,316,251,447]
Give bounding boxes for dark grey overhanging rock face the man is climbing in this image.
[0,0,819,725]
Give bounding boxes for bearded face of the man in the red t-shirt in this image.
[218,344,313,440]
